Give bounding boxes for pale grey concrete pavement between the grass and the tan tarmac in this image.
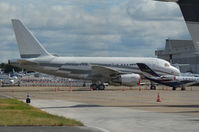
[31,100,199,132]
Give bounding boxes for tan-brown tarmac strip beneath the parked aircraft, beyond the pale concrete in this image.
[0,86,199,118]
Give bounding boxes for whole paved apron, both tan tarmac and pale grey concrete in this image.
[0,86,199,132]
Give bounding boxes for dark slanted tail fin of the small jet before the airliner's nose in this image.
[136,63,160,77]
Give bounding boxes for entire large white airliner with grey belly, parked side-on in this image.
[8,19,180,90]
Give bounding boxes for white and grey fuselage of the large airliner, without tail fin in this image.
[10,56,177,81]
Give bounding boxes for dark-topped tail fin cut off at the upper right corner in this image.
[156,0,199,54]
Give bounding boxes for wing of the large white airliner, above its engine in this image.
[91,65,121,78]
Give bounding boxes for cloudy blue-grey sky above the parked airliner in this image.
[0,0,190,62]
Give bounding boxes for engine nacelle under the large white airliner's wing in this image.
[112,73,141,86]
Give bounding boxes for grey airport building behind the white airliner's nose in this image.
[155,39,199,74]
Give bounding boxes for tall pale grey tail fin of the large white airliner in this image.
[12,19,50,58]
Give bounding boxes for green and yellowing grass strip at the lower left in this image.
[0,99,83,126]
